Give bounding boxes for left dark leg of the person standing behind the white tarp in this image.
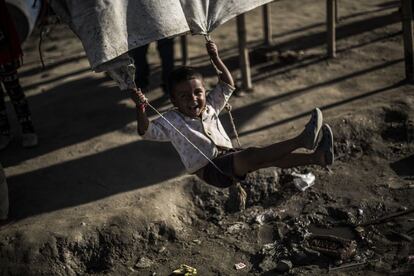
[130,44,150,92]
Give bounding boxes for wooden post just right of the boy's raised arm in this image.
[236,14,252,91]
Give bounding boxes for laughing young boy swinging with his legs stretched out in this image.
[132,41,334,188]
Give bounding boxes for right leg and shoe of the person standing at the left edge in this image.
[0,64,38,147]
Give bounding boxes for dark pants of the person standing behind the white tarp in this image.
[130,38,174,92]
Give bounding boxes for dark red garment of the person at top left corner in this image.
[0,0,23,64]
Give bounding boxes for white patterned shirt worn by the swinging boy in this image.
[143,82,235,173]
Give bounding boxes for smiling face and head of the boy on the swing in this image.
[171,78,206,118]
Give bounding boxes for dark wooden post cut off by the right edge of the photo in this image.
[401,0,414,82]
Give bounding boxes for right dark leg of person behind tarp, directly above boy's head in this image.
[157,38,174,93]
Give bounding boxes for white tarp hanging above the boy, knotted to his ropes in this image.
[50,0,272,89]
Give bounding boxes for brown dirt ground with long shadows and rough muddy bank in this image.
[0,0,414,275]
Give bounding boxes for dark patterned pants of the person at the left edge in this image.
[0,63,34,135]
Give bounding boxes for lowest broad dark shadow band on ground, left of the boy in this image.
[7,141,183,220]
